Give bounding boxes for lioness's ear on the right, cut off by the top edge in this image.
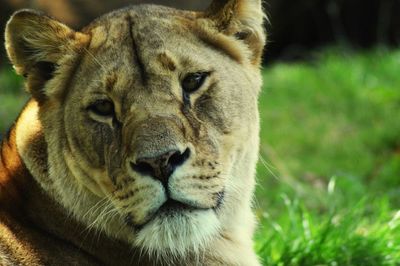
[204,0,266,64]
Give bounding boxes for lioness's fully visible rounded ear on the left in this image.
[5,9,89,101]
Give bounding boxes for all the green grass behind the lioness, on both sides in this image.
[0,48,400,266]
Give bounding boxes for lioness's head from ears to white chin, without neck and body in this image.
[7,1,264,258]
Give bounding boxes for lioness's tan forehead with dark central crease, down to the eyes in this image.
[75,5,222,89]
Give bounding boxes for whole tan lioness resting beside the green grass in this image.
[0,0,265,265]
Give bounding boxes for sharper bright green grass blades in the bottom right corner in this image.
[257,195,400,266]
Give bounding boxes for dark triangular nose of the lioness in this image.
[131,148,190,186]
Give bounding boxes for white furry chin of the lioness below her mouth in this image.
[134,209,220,257]
